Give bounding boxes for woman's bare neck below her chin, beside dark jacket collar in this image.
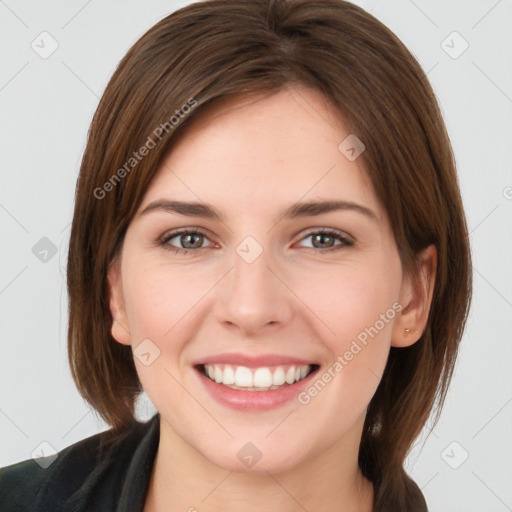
[144,418,373,512]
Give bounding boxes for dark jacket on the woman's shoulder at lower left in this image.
[0,414,160,512]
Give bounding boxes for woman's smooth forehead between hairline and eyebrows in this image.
[141,87,378,213]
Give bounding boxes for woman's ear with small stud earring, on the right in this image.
[391,245,437,347]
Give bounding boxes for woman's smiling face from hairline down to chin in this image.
[109,88,428,472]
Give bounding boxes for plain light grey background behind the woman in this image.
[0,0,512,512]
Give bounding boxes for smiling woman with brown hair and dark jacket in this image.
[0,0,471,512]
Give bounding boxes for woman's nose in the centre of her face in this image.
[216,242,293,336]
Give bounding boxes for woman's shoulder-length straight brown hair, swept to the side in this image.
[68,0,471,511]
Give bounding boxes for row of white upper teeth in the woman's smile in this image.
[204,364,311,391]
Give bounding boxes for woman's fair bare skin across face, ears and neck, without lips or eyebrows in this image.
[108,87,436,512]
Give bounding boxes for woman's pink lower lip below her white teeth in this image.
[195,368,318,411]
